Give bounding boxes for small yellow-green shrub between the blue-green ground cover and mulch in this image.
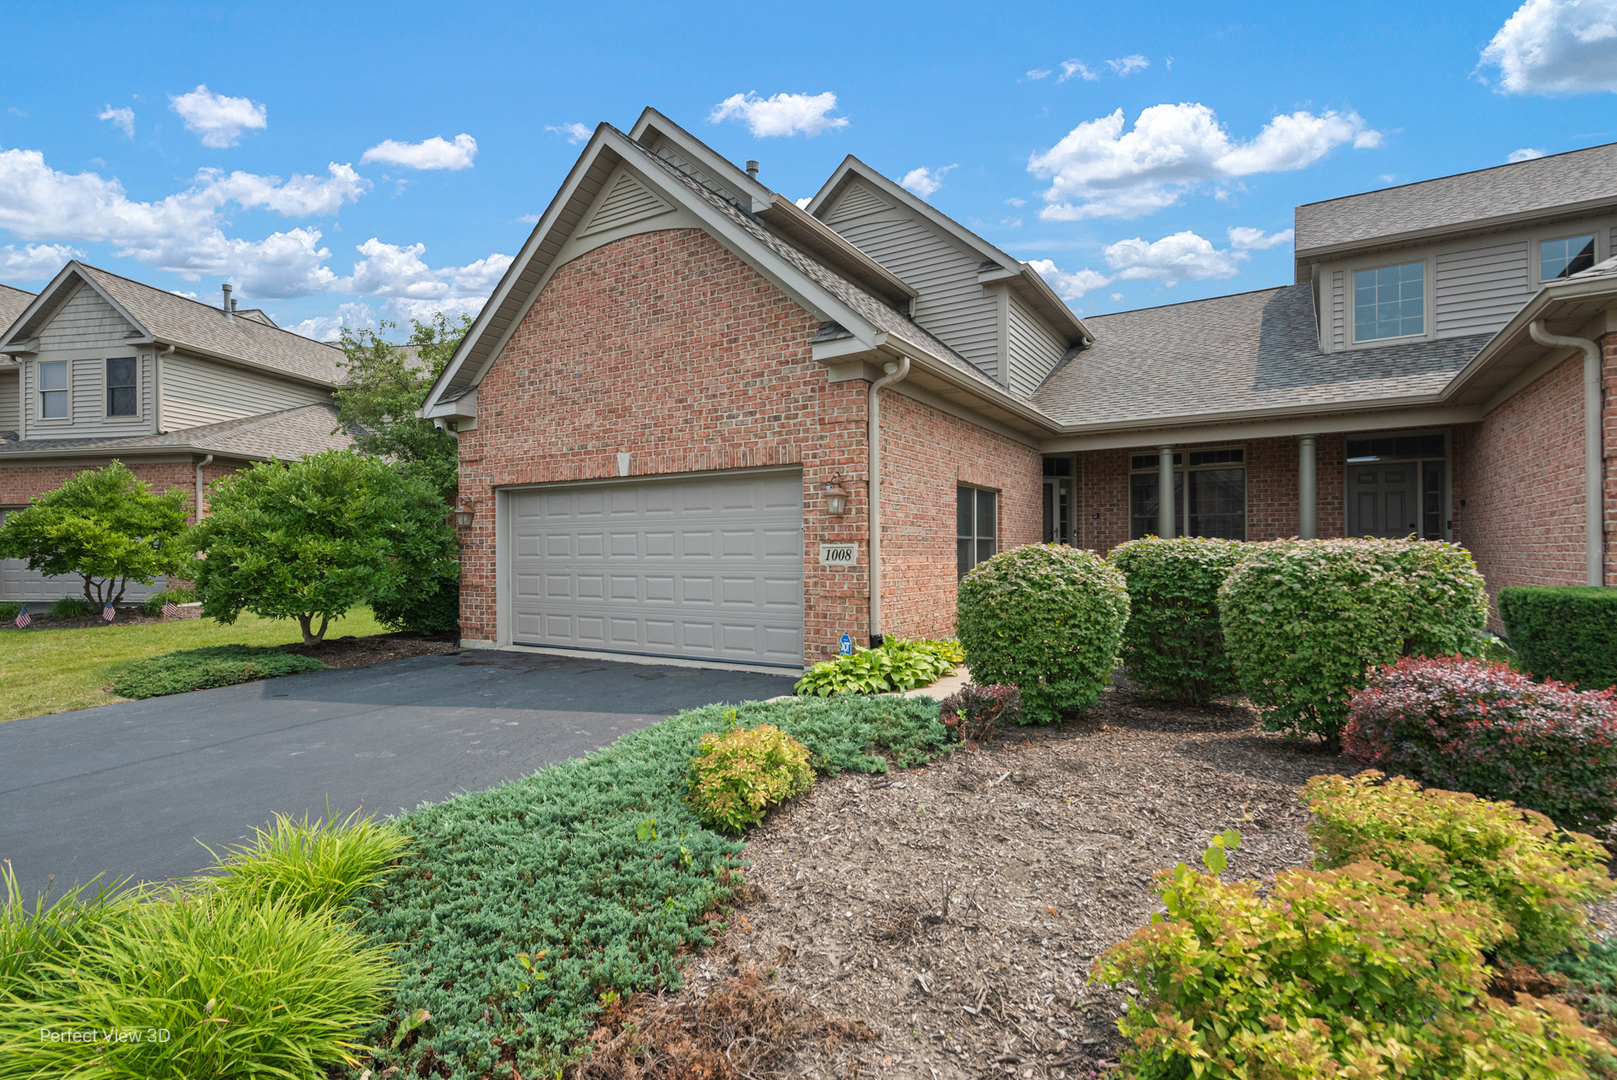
[690,724,813,833]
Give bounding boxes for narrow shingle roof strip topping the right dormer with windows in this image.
[1297,142,1617,254]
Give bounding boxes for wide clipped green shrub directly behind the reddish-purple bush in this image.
[1215,540,1488,744]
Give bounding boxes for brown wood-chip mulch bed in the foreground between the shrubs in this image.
[577,682,1349,1080]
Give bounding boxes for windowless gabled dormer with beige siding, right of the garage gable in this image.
[807,157,1091,394]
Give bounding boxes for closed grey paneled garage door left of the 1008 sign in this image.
[508,472,804,668]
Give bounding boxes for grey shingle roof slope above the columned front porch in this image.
[1032,283,1489,424]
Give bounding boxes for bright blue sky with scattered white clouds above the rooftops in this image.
[0,0,1617,336]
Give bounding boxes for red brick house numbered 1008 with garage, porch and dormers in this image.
[422,110,1617,668]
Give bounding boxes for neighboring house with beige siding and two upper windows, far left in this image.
[0,262,351,601]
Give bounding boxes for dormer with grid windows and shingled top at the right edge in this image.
[1295,144,1617,352]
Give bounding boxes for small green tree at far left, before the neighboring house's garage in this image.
[0,461,191,606]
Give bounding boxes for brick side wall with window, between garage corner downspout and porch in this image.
[881,390,1045,637]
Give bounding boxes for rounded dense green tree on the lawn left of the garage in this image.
[192,449,458,645]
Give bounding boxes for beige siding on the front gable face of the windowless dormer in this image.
[826,184,999,378]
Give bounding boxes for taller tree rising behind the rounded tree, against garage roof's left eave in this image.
[336,312,472,506]
